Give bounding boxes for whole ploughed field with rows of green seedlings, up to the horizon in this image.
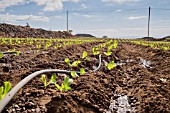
[0,38,170,113]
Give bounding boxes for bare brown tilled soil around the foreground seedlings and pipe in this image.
[0,42,170,113]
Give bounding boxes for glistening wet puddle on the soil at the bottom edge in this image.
[104,95,135,113]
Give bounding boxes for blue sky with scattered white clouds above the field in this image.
[0,0,170,38]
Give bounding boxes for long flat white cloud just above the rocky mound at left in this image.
[0,14,49,22]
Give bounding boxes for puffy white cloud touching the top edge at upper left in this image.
[0,0,80,11]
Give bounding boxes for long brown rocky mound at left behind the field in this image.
[0,23,73,38]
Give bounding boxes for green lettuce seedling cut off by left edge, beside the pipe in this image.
[0,81,12,100]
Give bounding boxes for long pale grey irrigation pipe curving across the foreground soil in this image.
[0,54,101,113]
